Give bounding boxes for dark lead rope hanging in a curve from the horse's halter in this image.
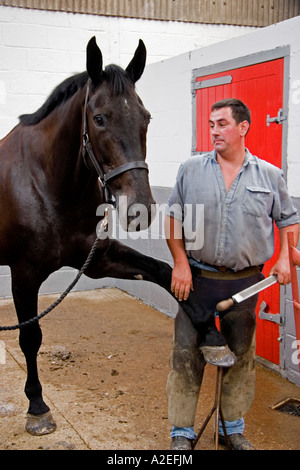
[0,209,108,331]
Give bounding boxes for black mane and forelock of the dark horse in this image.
[19,65,133,126]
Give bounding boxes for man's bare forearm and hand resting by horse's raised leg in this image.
[165,216,193,301]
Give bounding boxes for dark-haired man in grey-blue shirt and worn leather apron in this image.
[165,99,299,450]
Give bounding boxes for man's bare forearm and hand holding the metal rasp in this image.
[270,224,299,285]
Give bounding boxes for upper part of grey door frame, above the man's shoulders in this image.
[191,46,290,180]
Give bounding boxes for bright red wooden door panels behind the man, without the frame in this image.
[195,59,284,364]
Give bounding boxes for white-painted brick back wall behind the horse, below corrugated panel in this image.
[0,6,254,138]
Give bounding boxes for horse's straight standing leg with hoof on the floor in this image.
[12,270,56,436]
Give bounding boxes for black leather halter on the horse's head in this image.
[82,86,148,205]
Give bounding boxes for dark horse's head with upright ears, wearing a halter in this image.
[85,38,155,230]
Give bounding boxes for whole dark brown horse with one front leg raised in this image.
[0,38,225,435]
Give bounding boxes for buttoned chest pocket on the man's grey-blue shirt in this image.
[242,186,272,217]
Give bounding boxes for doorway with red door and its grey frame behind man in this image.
[192,47,289,365]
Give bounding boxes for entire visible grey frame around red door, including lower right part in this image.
[191,45,291,372]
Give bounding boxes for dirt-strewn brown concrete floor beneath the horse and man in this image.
[0,289,300,450]
